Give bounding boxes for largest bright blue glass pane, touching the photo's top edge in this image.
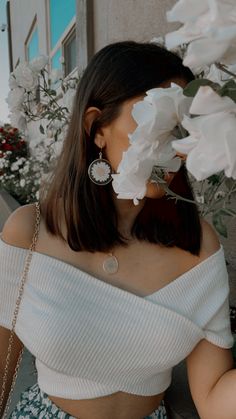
[49,0,76,49]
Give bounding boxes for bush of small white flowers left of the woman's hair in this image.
[3,56,78,204]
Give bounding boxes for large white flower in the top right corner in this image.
[166,0,236,69]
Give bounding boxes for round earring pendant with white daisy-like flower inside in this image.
[88,157,112,186]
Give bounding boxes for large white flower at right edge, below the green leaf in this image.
[172,86,236,180]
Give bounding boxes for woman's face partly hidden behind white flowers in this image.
[100,95,174,198]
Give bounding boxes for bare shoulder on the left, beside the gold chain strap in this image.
[2,204,35,248]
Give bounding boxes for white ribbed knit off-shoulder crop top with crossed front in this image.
[0,240,233,400]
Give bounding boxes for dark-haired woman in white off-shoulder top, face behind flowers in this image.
[0,42,236,419]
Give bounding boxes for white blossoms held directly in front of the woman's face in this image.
[112,83,192,205]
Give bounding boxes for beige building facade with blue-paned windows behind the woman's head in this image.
[8,0,177,76]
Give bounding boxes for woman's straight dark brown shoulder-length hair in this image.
[41,41,201,254]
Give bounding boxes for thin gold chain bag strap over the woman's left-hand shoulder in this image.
[0,202,40,419]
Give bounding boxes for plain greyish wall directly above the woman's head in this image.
[93,0,176,51]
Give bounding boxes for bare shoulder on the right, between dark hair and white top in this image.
[200,219,220,259]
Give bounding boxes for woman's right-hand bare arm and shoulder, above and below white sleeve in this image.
[187,221,236,419]
